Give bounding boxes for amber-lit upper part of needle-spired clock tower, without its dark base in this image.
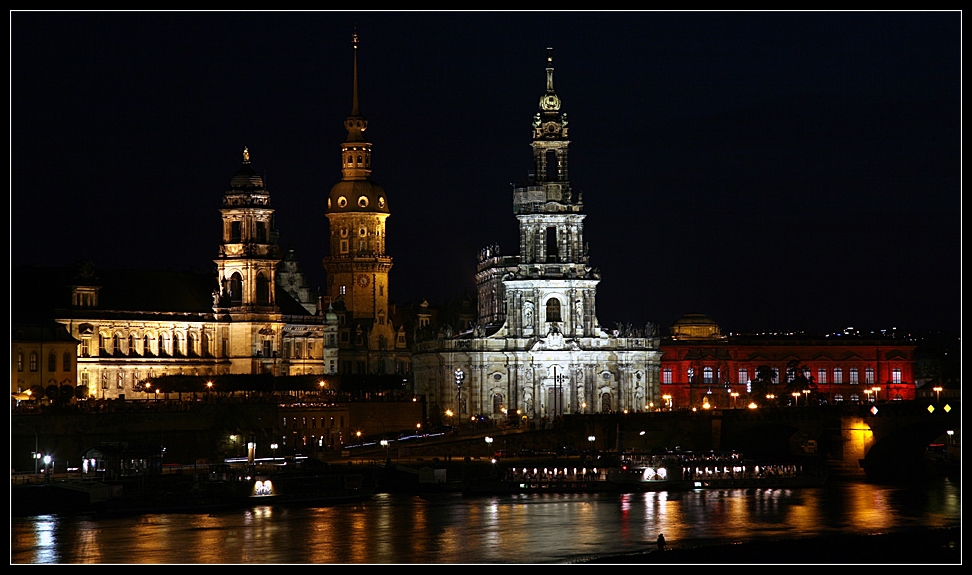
[323,34,392,321]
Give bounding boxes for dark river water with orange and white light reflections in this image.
[10,480,961,564]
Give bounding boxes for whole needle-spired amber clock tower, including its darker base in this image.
[323,34,404,373]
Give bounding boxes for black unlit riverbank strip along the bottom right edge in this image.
[579,528,962,565]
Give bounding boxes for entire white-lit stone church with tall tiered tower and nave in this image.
[412,49,661,421]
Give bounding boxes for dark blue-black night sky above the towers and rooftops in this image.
[10,11,962,333]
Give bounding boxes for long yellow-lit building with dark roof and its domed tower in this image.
[11,150,338,399]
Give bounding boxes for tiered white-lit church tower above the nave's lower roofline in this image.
[477,48,600,338]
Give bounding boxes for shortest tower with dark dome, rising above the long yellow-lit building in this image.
[213,148,280,312]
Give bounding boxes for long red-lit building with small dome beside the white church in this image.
[660,314,916,409]
